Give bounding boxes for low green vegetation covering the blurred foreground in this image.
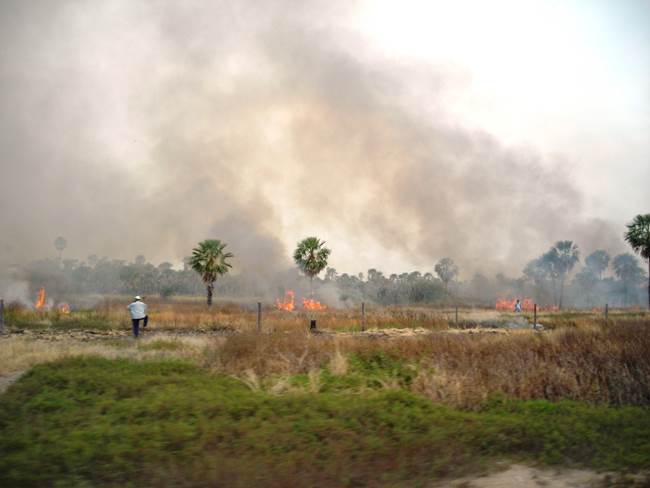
[0,353,650,487]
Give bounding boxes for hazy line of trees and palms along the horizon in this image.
[10,214,650,309]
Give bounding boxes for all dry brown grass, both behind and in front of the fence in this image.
[5,302,650,408]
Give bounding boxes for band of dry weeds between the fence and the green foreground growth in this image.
[0,314,650,409]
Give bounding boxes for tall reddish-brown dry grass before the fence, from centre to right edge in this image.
[197,321,650,408]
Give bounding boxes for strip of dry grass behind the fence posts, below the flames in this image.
[6,298,650,332]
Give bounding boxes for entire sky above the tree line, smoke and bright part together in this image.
[0,0,650,273]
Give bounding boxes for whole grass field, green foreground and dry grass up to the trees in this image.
[0,302,650,487]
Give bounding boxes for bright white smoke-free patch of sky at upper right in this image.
[354,0,650,219]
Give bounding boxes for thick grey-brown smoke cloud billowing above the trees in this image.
[0,0,620,280]
